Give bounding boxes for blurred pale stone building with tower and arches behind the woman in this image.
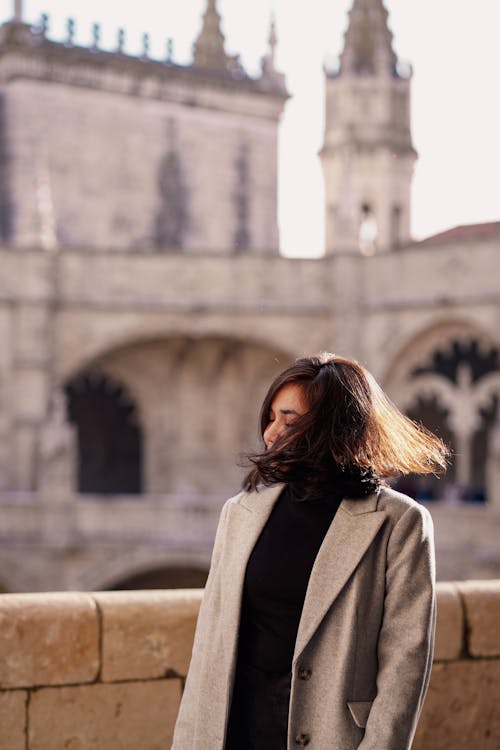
[0,0,500,591]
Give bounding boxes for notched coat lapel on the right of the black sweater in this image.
[293,494,386,662]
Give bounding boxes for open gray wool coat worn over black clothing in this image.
[172,484,435,750]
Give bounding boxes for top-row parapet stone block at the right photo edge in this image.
[457,580,500,657]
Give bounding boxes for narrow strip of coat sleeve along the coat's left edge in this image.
[171,500,231,750]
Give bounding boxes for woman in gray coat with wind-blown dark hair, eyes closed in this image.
[173,354,447,750]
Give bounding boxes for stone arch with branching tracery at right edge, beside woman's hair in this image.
[384,321,500,504]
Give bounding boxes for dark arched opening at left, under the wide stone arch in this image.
[65,371,142,495]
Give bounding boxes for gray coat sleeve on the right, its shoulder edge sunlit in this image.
[358,505,436,750]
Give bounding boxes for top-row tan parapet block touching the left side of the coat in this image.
[94,589,201,682]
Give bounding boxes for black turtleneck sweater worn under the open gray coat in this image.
[238,486,341,674]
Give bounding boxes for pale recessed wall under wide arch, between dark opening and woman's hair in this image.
[66,335,292,497]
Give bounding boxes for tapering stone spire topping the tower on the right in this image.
[340,0,397,75]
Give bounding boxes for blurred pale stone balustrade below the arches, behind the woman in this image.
[0,500,500,592]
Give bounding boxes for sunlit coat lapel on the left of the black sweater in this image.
[222,484,284,670]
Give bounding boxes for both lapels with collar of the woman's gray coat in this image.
[223,484,386,664]
